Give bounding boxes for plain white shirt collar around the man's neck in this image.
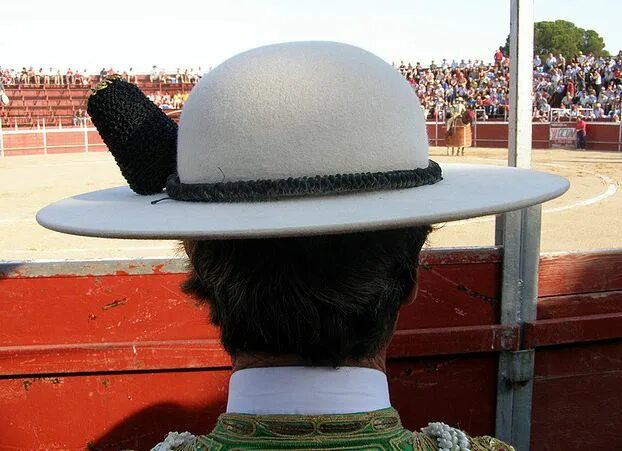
[227,366,391,415]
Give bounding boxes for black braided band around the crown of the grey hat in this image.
[166,160,443,202]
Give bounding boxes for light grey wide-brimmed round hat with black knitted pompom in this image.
[37,42,569,239]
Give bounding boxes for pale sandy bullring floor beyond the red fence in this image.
[0,148,622,261]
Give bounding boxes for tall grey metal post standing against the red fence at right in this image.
[495,0,542,451]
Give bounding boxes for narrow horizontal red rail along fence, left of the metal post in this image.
[0,326,518,377]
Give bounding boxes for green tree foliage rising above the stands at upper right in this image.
[501,20,609,58]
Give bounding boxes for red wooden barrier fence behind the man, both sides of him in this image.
[0,249,622,451]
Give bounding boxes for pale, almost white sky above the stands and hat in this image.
[0,0,622,71]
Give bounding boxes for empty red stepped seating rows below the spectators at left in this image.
[0,75,193,128]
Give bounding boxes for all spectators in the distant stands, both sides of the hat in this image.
[0,49,622,121]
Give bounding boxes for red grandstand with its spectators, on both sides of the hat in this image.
[0,54,622,128]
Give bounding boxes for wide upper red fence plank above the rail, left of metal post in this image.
[0,253,508,346]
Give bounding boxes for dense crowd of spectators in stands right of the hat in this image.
[393,49,622,121]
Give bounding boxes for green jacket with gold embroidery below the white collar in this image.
[175,408,514,451]
